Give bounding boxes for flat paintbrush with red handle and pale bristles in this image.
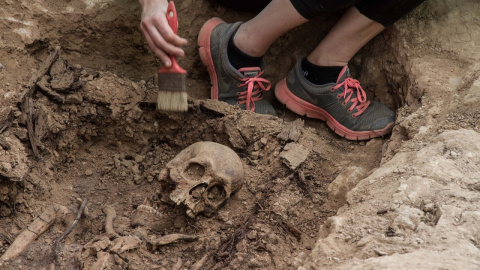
[157,1,188,112]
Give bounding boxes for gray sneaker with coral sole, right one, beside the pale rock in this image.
[275,59,395,140]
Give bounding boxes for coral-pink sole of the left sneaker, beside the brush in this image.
[197,18,224,99]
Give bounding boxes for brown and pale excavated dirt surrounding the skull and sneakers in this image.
[0,0,480,269]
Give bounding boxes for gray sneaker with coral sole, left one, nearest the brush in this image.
[198,18,276,115]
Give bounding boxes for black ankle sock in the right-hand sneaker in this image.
[302,58,343,85]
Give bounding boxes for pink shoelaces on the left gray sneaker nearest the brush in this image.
[237,68,272,111]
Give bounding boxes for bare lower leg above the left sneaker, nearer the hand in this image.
[233,0,308,57]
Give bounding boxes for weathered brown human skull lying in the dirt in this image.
[159,142,244,218]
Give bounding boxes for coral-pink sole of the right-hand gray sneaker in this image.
[275,79,393,140]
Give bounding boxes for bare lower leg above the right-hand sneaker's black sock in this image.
[307,7,385,66]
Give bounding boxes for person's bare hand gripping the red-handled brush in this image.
[139,0,188,67]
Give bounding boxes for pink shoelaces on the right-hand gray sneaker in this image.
[332,77,370,118]
